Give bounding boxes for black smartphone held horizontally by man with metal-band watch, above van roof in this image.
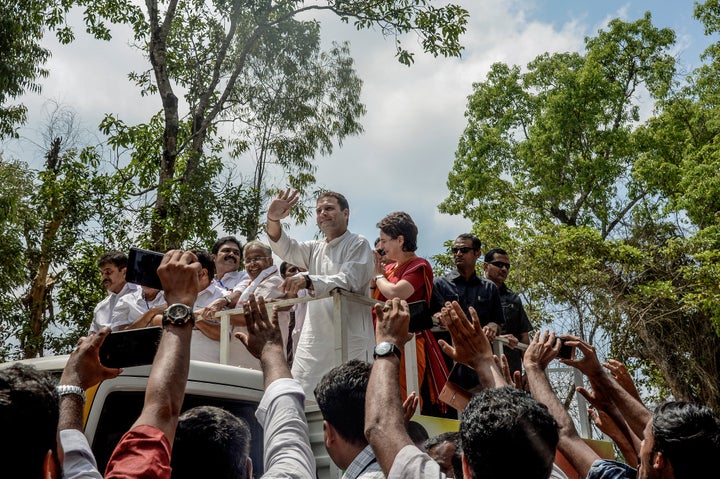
[100,326,163,368]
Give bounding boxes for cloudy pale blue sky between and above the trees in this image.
[4,0,709,258]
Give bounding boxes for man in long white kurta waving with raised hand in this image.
[267,190,375,398]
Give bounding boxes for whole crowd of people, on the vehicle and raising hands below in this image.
[0,190,720,479]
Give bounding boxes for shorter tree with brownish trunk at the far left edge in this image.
[0,107,111,358]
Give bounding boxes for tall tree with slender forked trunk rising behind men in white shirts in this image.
[95,0,467,250]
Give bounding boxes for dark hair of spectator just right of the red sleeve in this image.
[170,406,250,479]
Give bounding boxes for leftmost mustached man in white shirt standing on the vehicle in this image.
[89,251,137,334]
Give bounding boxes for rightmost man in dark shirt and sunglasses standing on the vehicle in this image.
[483,248,532,374]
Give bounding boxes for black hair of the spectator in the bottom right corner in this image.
[652,401,720,479]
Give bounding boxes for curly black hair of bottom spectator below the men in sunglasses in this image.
[460,386,559,479]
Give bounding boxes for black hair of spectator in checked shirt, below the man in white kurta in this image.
[314,359,371,446]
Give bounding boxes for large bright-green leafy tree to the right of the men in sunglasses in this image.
[440,13,720,406]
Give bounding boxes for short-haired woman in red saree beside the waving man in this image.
[370,211,449,409]
